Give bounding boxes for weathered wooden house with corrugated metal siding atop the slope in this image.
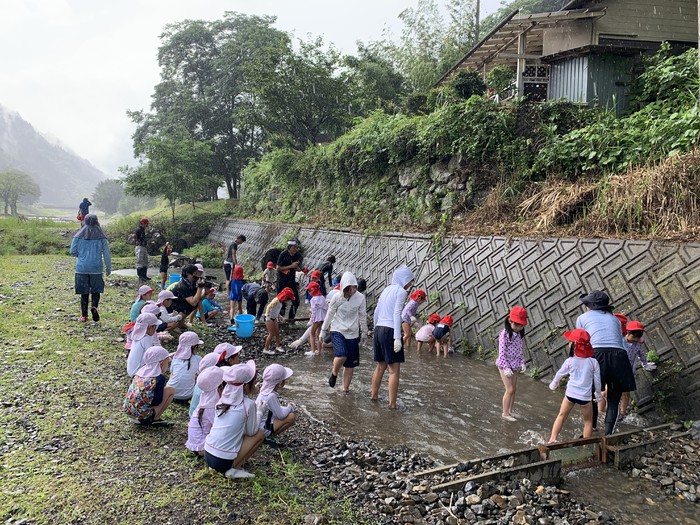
[436,0,698,111]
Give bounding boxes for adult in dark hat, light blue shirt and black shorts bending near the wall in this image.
[576,290,637,436]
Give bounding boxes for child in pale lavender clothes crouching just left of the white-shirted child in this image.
[185,366,224,456]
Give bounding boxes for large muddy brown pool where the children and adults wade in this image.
[285,347,652,461]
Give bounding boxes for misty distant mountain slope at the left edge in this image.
[0,106,107,209]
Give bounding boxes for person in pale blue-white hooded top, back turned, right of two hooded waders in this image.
[371,266,414,410]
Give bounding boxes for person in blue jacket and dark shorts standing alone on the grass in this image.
[70,213,112,323]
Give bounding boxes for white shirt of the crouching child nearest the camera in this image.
[204,397,258,459]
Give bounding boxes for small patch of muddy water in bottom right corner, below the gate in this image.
[562,466,700,525]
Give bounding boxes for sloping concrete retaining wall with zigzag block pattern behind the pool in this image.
[210,220,700,414]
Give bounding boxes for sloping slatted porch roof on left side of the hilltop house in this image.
[435,6,605,85]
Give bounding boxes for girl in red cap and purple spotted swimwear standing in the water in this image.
[494,306,528,421]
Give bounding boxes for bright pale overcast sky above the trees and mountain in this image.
[0,0,499,176]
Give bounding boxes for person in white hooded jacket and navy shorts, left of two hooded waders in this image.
[321,272,368,393]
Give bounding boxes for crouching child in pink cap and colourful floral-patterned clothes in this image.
[124,346,175,425]
